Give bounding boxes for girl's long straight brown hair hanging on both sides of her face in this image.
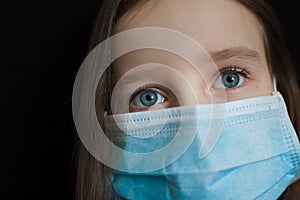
[75,0,300,200]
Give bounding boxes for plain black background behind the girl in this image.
[0,0,300,199]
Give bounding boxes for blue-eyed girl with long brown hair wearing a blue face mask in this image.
[73,0,300,199]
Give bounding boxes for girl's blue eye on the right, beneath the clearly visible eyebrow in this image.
[214,68,248,88]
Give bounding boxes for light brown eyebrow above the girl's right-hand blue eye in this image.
[209,46,261,61]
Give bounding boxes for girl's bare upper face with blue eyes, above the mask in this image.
[113,0,273,113]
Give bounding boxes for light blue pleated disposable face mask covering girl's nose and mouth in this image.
[106,93,300,200]
